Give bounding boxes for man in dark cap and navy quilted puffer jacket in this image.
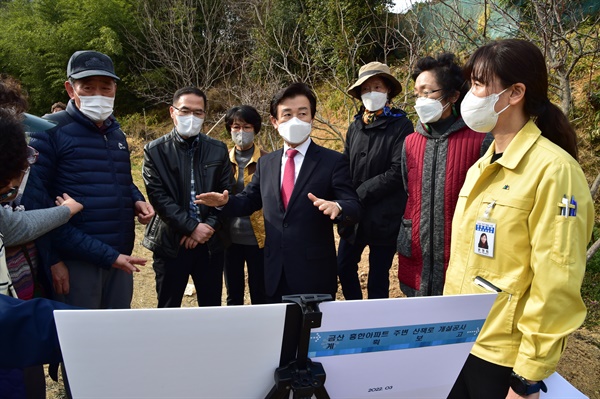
[30,51,154,309]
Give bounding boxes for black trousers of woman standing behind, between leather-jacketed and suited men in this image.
[225,244,266,305]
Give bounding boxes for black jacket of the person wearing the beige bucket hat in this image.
[340,109,414,245]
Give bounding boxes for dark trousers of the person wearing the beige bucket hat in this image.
[337,237,396,300]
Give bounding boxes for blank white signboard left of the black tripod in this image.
[55,305,291,399]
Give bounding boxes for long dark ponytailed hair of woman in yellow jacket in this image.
[464,39,577,159]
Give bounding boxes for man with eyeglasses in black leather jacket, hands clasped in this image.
[143,87,231,308]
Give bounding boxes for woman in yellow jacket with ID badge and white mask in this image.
[444,39,594,399]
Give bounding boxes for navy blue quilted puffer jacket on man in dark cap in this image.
[24,100,144,268]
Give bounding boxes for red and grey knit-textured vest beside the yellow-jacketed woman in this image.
[398,119,487,296]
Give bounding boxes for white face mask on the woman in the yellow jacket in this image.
[460,88,510,133]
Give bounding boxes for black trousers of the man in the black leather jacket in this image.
[153,244,223,308]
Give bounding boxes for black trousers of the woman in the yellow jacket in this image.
[448,355,512,399]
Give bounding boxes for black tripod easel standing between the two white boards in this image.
[266,294,331,399]
